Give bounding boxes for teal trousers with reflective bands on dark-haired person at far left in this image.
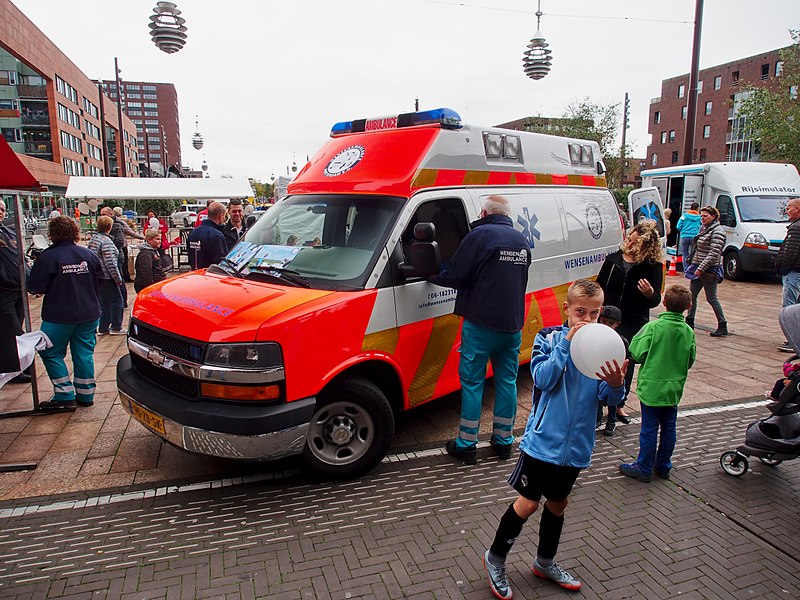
[39,319,97,404]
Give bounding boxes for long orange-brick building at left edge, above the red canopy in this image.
[0,0,139,195]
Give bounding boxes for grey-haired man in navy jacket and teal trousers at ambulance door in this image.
[430,196,531,465]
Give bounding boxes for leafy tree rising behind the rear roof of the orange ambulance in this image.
[525,98,630,184]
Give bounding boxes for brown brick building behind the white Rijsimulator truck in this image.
[645,49,796,168]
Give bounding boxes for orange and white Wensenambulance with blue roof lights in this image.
[117,109,658,477]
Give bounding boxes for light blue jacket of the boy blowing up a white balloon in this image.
[519,325,625,469]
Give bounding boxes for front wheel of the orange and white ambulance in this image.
[303,378,394,478]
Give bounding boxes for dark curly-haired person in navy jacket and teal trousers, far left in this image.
[28,217,104,410]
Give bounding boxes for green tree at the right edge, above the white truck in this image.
[739,29,800,168]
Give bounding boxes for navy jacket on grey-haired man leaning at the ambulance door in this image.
[430,215,531,333]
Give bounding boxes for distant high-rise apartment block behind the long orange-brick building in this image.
[100,80,182,177]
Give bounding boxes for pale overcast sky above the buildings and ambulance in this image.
[7,0,800,181]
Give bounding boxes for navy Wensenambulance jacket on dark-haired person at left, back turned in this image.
[28,241,105,323]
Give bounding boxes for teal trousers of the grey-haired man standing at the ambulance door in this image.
[456,319,522,448]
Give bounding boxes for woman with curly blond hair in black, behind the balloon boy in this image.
[597,221,664,435]
